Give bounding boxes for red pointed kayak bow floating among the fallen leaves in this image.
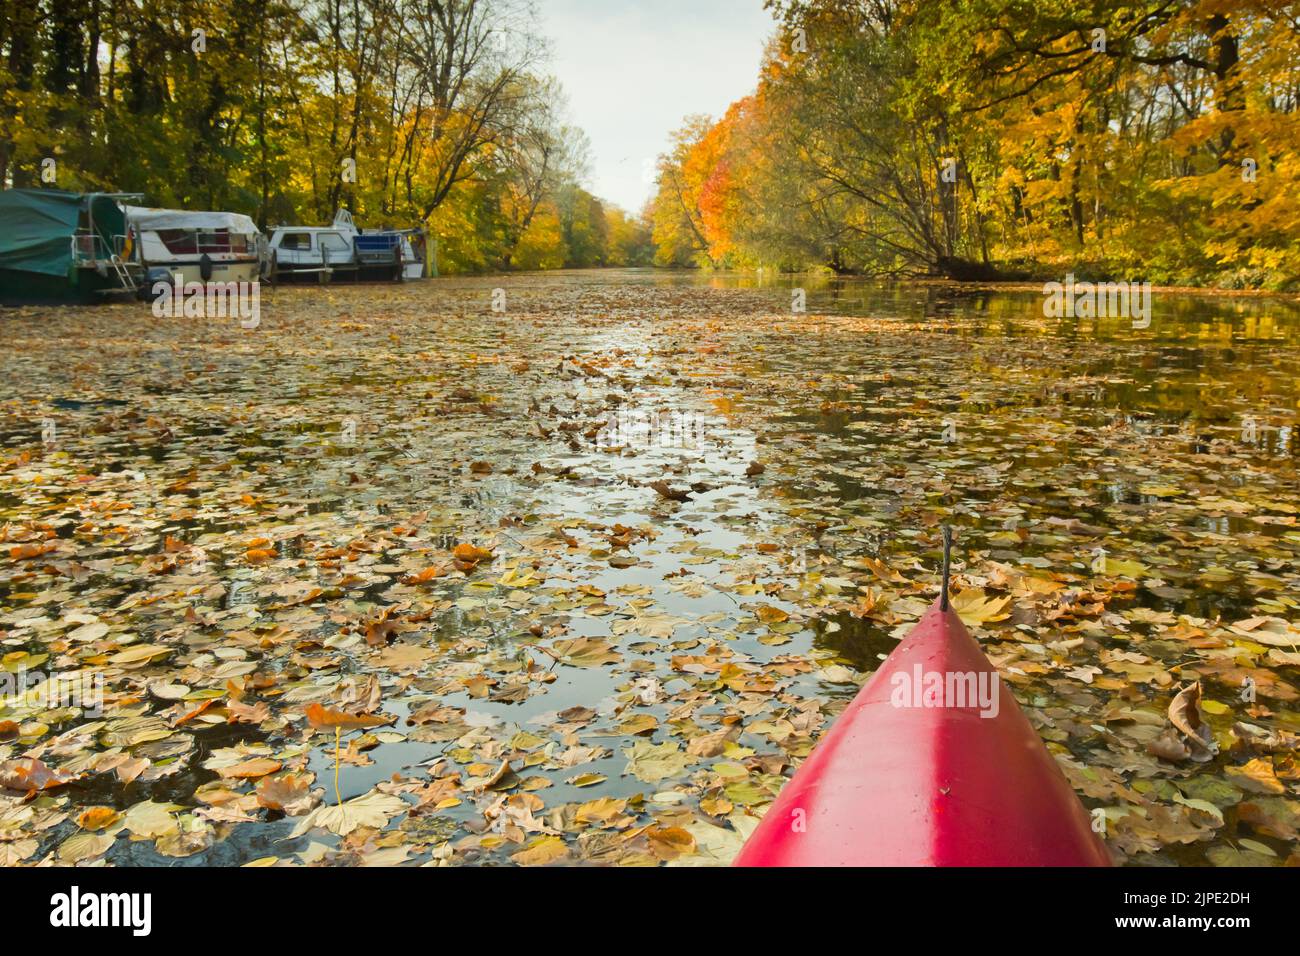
[733,530,1112,866]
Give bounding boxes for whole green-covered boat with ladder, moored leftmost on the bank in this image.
[0,189,126,276]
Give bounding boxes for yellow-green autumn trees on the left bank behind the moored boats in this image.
[0,0,653,269]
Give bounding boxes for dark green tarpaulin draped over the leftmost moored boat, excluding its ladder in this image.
[0,189,87,276]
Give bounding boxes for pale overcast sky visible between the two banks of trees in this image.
[537,0,775,212]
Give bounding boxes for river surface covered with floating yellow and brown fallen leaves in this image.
[0,272,1300,865]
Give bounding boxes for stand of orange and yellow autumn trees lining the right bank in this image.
[654,0,1300,289]
